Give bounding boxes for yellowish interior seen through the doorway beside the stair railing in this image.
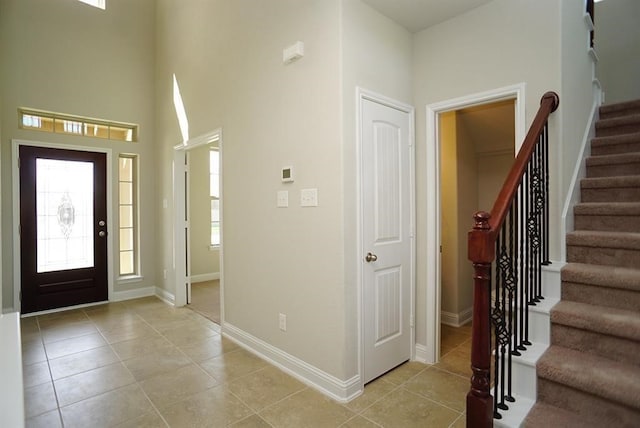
[438,99,515,364]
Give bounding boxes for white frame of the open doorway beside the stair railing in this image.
[421,83,526,364]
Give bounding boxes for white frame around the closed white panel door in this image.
[356,87,416,388]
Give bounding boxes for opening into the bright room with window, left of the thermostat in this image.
[187,141,220,324]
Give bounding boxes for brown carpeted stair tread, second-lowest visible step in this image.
[537,345,640,411]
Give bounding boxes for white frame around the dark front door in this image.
[11,139,116,312]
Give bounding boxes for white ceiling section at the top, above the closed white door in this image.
[362,0,492,33]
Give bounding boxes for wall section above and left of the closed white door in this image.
[340,0,412,380]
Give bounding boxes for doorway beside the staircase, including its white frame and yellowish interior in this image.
[423,84,525,364]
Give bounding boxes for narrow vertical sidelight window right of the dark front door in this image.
[118,154,139,276]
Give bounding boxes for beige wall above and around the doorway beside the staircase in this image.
[413,0,560,344]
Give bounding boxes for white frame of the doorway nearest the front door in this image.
[173,128,224,314]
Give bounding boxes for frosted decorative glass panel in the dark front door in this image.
[36,159,94,273]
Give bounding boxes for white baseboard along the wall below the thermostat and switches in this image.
[222,322,362,403]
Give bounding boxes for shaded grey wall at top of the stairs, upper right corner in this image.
[594,0,640,104]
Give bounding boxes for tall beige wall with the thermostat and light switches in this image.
[156,0,352,380]
